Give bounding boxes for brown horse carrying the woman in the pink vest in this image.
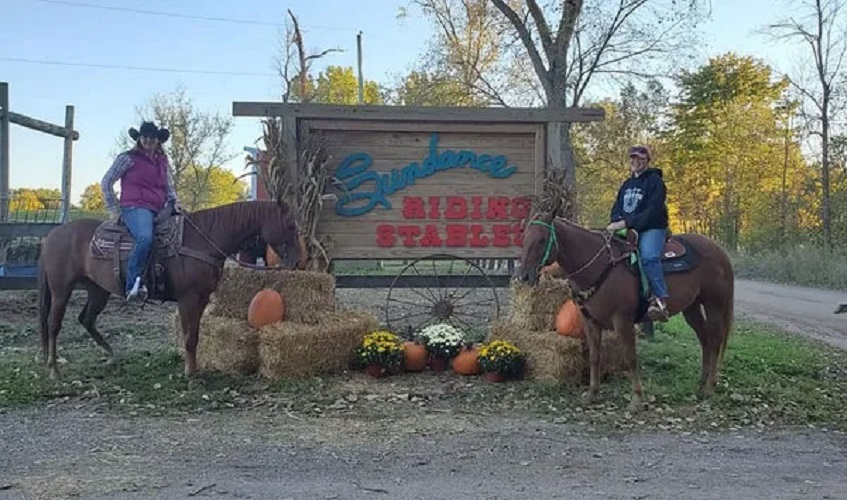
[38,201,301,379]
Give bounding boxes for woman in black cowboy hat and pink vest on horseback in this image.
[100,122,180,302]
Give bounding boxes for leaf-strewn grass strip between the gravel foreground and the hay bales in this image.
[0,318,847,431]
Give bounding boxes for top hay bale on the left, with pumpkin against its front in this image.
[209,266,335,324]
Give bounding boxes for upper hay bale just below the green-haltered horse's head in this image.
[509,274,571,332]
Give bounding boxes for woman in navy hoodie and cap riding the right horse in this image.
[606,146,668,321]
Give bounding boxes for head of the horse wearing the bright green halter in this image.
[518,200,562,286]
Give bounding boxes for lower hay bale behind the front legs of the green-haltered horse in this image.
[490,321,627,384]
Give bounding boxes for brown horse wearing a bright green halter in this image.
[519,201,735,412]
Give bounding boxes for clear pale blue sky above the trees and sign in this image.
[0,0,804,203]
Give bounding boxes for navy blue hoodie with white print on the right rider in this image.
[611,167,668,232]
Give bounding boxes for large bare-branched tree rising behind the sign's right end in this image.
[408,0,708,215]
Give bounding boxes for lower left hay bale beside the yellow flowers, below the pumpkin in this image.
[259,311,379,379]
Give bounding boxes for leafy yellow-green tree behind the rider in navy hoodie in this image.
[666,53,804,249]
